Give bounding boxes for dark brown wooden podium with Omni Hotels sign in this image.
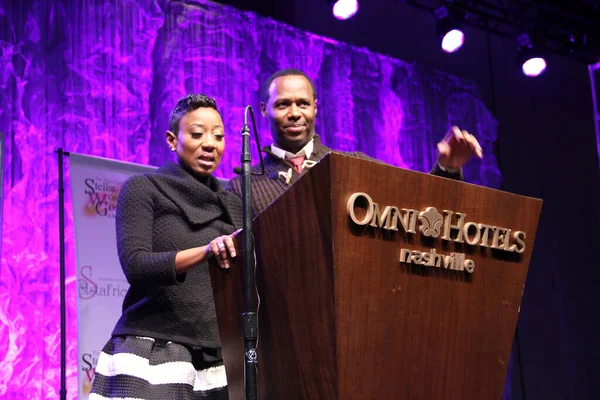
[211,153,542,400]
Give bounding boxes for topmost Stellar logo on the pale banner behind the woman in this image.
[84,177,123,218]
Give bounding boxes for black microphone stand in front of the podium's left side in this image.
[241,106,264,400]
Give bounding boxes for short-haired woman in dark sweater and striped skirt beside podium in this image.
[90,94,242,399]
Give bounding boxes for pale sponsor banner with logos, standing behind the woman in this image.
[69,153,155,400]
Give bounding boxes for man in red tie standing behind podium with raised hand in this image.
[227,69,482,215]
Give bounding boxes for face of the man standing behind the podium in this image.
[260,75,317,153]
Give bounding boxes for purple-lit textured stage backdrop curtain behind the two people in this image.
[0,0,501,399]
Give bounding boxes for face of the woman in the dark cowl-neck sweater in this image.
[167,108,225,176]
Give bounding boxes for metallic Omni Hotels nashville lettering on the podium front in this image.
[347,192,526,273]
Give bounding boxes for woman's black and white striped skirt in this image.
[89,336,228,400]
